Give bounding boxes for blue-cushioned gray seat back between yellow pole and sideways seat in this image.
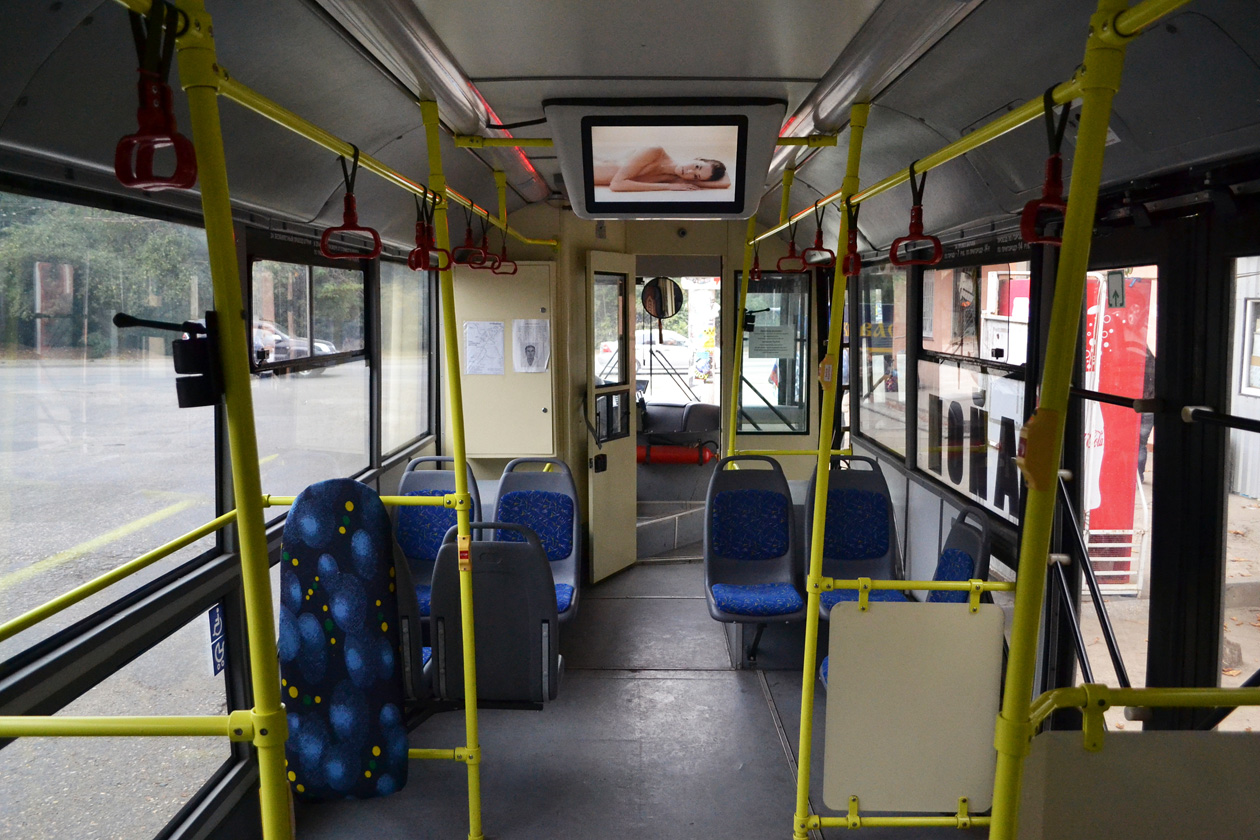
[805,455,903,581]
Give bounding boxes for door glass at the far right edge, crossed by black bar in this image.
[1220,257,1260,730]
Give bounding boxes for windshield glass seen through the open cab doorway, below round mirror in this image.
[634,277,722,406]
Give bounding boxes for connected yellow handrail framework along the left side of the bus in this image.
[0,0,491,840]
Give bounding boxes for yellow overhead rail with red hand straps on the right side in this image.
[750,0,1189,244]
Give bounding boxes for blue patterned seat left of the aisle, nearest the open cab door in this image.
[494,458,582,622]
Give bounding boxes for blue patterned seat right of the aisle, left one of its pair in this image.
[704,456,805,644]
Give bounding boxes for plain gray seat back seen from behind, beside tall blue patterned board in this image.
[430,523,559,705]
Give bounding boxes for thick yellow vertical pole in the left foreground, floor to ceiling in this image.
[172,0,292,840]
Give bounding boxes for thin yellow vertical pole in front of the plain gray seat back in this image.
[420,101,483,840]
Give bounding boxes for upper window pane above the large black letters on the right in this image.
[924,262,1032,365]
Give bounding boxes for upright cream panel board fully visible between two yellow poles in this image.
[823,602,1002,814]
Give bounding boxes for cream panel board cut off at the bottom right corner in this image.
[1018,732,1260,840]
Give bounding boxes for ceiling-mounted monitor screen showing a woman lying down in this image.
[581,115,748,215]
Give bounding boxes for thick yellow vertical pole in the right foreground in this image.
[989,0,1129,840]
